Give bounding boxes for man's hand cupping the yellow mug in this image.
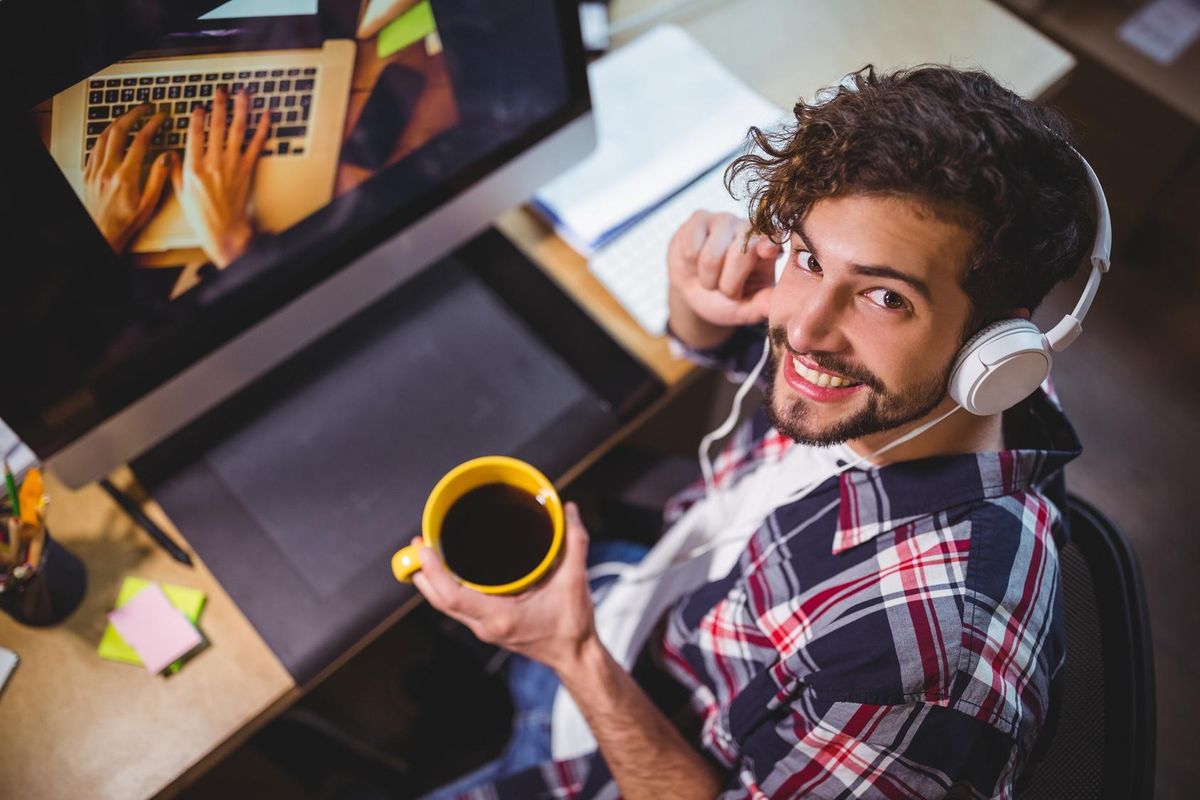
[413,503,595,670]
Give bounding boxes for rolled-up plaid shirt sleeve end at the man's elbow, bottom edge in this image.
[720,702,1016,800]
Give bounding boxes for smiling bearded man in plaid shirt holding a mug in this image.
[416,67,1094,799]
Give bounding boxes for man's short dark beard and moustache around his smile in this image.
[764,327,952,447]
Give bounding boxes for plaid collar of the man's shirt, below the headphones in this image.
[833,389,1081,554]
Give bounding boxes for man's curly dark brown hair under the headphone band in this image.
[726,65,1096,338]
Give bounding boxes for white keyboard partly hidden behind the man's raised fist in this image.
[588,163,746,336]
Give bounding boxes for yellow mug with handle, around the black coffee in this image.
[391,456,565,595]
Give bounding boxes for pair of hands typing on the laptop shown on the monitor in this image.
[84,89,270,267]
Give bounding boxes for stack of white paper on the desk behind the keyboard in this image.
[534,25,779,255]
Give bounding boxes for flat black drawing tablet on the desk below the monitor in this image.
[133,231,662,685]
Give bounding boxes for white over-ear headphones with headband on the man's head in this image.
[949,148,1112,416]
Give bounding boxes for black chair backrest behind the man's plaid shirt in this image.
[1016,495,1154,800]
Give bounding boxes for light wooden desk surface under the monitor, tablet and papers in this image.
[0,0,1073,799]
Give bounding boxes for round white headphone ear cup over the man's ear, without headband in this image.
[948,319,1054,416]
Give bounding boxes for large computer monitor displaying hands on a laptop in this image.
[0,0,594,486]
